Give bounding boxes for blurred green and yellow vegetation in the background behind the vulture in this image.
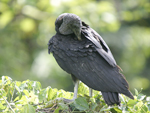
[0,0,150,95]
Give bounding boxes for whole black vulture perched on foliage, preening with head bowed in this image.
[48,13,134,105]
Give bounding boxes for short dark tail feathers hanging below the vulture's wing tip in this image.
[102,92,121,106]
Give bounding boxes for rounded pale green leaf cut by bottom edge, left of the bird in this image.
[21,104,35,113]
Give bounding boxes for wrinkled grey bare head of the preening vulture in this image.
[55,13,82,40]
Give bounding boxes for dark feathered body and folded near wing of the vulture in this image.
[51,34,132,98]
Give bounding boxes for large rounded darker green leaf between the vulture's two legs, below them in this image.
[74,97,89,111]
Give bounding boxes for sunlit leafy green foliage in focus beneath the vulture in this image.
[0,76,150,113]
